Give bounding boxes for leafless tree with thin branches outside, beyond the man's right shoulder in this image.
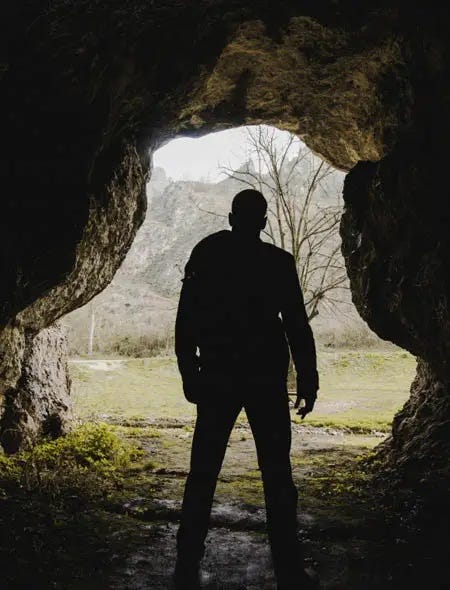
[222,126,347,320]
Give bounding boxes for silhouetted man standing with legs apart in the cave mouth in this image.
[175,190,318,590]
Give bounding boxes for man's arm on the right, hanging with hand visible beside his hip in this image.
[281,256,319,418]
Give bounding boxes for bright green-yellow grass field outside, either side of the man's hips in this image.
[70,350,415,433]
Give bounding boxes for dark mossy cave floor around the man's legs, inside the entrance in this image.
[0,421,436,590]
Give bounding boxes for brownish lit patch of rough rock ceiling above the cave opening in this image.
[176,17,408,170]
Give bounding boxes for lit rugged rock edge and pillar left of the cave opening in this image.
[0,147,146,452]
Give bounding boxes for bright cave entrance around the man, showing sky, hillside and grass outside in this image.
[55,127,415,588]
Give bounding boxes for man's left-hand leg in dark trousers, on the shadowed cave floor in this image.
[177,398,242,567]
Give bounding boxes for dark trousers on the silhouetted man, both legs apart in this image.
[177,385,303,583]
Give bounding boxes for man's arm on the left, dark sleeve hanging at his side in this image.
[175,260,199,402]
